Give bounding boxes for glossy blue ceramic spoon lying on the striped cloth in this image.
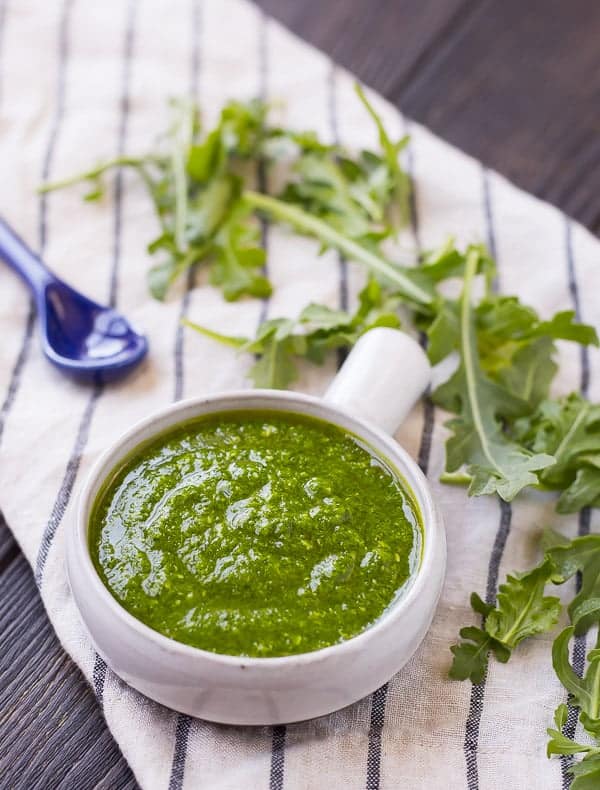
[0,219,148,381]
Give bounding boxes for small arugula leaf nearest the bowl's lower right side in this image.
[449,560,561,683]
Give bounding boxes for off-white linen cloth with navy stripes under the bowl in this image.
[0,0,600,790]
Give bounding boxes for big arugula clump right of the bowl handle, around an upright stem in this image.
[399,242,600,511]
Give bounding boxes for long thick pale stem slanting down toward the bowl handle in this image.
[243,190,433,305]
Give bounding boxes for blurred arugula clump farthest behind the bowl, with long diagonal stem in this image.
[42,86,418,304]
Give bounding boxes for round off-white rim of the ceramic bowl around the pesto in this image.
[74,389,443,669]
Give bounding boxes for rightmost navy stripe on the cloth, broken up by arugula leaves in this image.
[560,217,591,790]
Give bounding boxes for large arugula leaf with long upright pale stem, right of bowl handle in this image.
[433,250,554,501]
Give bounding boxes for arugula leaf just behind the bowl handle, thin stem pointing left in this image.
[184,280,400,389]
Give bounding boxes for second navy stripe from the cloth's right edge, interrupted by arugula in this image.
[463,166,512,790]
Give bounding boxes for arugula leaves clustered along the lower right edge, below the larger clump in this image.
[450,530,600,790]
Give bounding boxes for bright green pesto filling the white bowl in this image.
[90,411,421,656]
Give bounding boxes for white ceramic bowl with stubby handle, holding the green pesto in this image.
[67,330,446,724]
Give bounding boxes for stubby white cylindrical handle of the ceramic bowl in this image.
[324,327,431,440]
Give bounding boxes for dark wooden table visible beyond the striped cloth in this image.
[0,0,600,790]
